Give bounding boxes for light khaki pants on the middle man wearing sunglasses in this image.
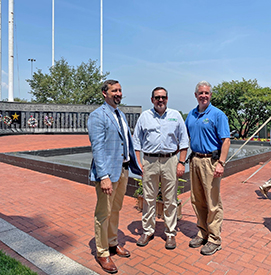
[142,155,178,236]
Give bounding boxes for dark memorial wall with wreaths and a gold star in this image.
[0,101,142,135]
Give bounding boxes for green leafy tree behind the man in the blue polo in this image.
[212,78,271,138]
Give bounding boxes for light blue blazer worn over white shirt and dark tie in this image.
[87,103,142,182]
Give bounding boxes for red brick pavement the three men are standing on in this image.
[0,135,271,275]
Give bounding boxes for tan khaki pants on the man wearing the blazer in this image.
[94,168,129,257]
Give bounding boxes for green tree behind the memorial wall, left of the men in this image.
[26,58,108,104]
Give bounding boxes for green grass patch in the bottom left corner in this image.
[0,250,38,275]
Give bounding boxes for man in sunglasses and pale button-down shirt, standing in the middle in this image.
[133,87,188,249]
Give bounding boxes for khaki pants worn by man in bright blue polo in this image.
[190,157,223,244]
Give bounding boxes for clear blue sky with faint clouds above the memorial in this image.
[2,0,271,113]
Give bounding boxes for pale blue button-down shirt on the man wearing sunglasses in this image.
[133,108,189,154]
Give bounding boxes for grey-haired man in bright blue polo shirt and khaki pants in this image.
[185,81,230,255]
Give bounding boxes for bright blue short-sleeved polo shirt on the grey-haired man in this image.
[185,103,230,154]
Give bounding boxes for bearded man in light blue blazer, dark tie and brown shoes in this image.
[88,80,142,273]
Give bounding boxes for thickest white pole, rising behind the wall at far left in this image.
[8,0,14,101]
